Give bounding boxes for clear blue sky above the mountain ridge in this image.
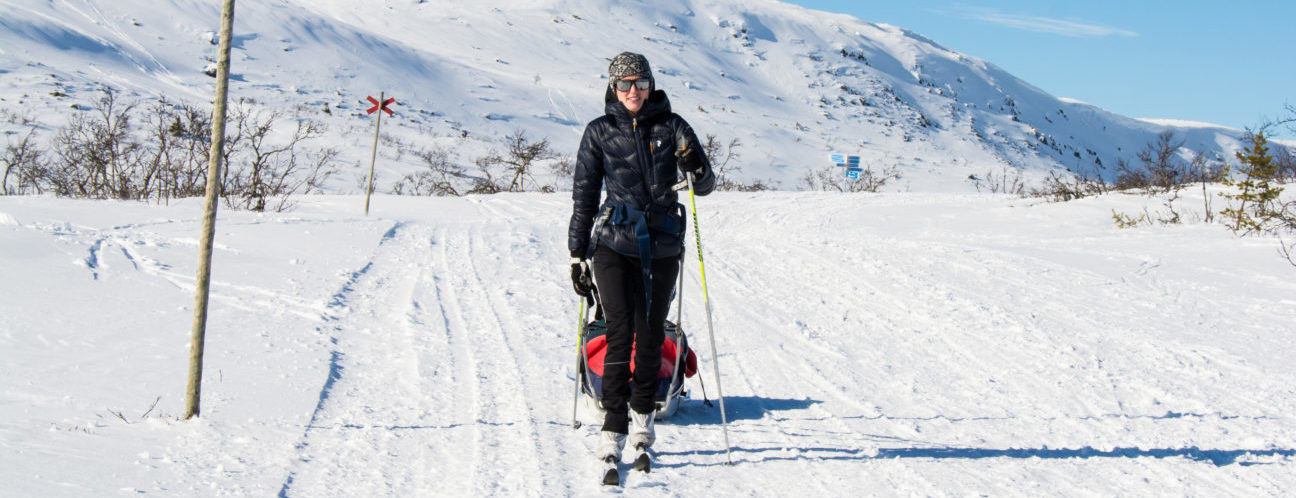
[784,0,1296,137]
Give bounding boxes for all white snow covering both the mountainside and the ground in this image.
[0,0,1296,497]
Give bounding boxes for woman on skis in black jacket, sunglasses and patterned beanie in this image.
[568,52,715,474]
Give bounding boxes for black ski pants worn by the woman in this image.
[591,245,679,434]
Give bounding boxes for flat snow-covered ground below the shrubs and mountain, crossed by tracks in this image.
[0,192,1296,497]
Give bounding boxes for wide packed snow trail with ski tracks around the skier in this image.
[268,191,1291,495]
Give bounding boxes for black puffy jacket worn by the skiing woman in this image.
[568,89,715,258]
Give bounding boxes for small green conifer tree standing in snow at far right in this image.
[1220,131,1283,232]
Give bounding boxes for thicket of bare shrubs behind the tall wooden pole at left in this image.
[9,88,337,210]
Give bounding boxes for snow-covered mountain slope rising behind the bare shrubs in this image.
[0,0,1240,191]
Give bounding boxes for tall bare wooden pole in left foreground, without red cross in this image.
[184,0,235,419]
